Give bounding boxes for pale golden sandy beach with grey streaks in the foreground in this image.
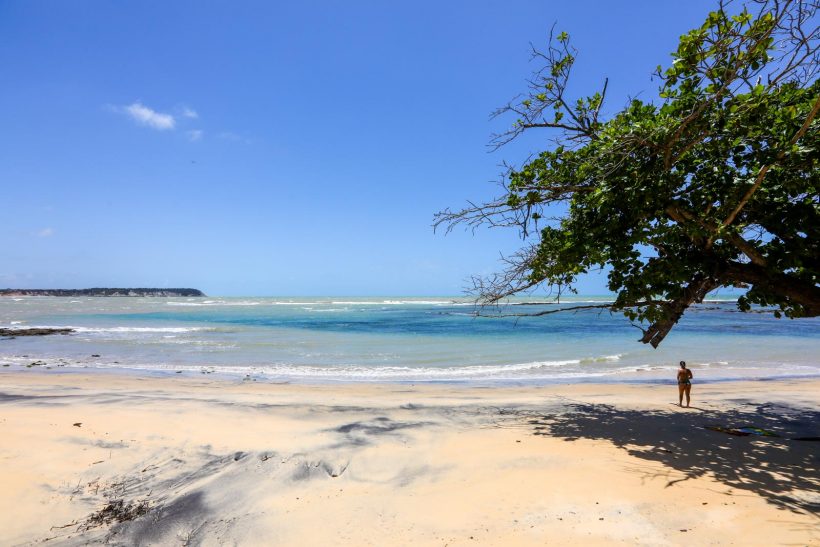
[0,371,820,546]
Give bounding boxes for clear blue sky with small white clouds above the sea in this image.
[0,0,715,295]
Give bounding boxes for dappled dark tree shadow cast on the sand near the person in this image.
[529,403,820,515]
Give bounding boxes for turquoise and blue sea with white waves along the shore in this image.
[0,297,820,383]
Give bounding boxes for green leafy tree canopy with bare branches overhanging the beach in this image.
[435,0,820,347]
